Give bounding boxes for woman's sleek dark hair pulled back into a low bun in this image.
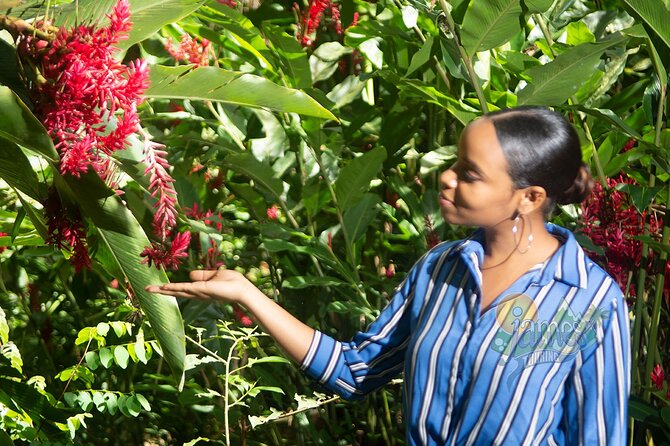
[485,107,593,212]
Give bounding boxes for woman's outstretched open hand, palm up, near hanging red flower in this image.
[145,269,260,304]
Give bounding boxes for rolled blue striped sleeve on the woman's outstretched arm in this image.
[301,258,426,399]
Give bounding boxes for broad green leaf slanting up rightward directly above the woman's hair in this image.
[518,37,626,105]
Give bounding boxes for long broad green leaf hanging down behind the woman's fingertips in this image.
[59,172,186,385]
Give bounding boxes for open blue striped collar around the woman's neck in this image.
[452,223,588,288]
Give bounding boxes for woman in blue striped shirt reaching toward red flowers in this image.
[149,107,629,445]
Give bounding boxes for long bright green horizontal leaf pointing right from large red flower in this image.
[146,65,337,120]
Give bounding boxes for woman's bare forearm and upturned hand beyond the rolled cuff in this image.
[146,270,314,363]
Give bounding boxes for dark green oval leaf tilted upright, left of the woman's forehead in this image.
[335,147,386,210]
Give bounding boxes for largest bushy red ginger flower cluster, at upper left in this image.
[18,0,148,179]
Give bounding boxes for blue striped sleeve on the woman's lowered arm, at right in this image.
[563,286,630,446]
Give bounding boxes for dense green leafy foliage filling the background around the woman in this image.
[0,0,670,445]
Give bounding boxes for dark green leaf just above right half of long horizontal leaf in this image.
[263,24,312,88]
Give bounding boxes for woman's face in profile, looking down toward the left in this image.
[439,118,521,228]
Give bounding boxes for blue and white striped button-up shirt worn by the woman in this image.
[302,224,630,446]
